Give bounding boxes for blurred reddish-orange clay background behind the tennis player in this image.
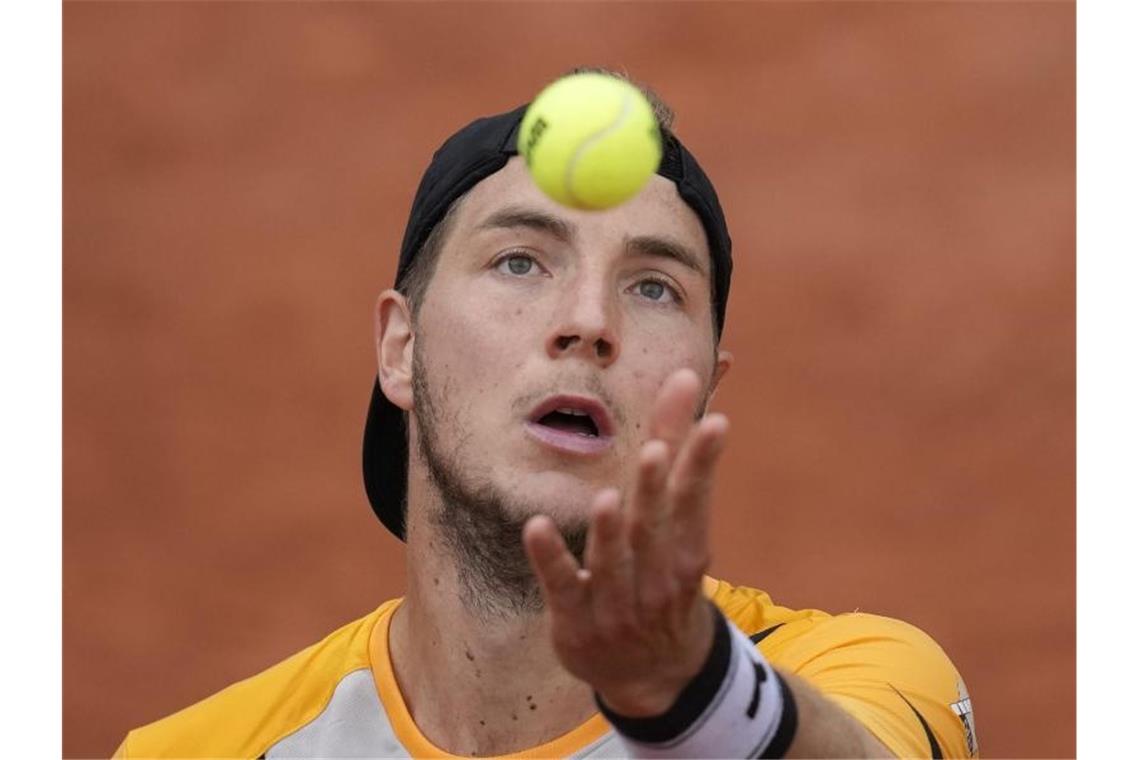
[64,2,1075,757]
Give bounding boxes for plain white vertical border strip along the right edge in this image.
[1076,0,1140,758]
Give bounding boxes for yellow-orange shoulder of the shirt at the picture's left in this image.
[115,600,394,758]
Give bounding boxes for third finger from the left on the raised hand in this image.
[629,440,673,619]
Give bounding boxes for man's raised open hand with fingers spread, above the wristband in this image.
[523,369,728,718]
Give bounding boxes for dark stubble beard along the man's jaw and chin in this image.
[412,344,587,620]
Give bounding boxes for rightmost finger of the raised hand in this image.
[667,414,728,587]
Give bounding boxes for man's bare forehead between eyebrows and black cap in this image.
[440,156,709,266]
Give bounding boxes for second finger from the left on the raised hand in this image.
[586,489,636,637]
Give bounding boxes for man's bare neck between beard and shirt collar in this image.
[390,509,595,755]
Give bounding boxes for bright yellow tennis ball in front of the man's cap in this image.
[519,73,661,210]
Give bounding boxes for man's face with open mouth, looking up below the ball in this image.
[412,157,727,533]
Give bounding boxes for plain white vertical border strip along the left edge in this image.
[0,2,63,757]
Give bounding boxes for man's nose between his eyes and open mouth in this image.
[546,276,621,368]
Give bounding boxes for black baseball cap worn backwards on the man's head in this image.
[364,99,732,540]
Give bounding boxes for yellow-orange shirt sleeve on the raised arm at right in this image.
[760,613,978,758]
